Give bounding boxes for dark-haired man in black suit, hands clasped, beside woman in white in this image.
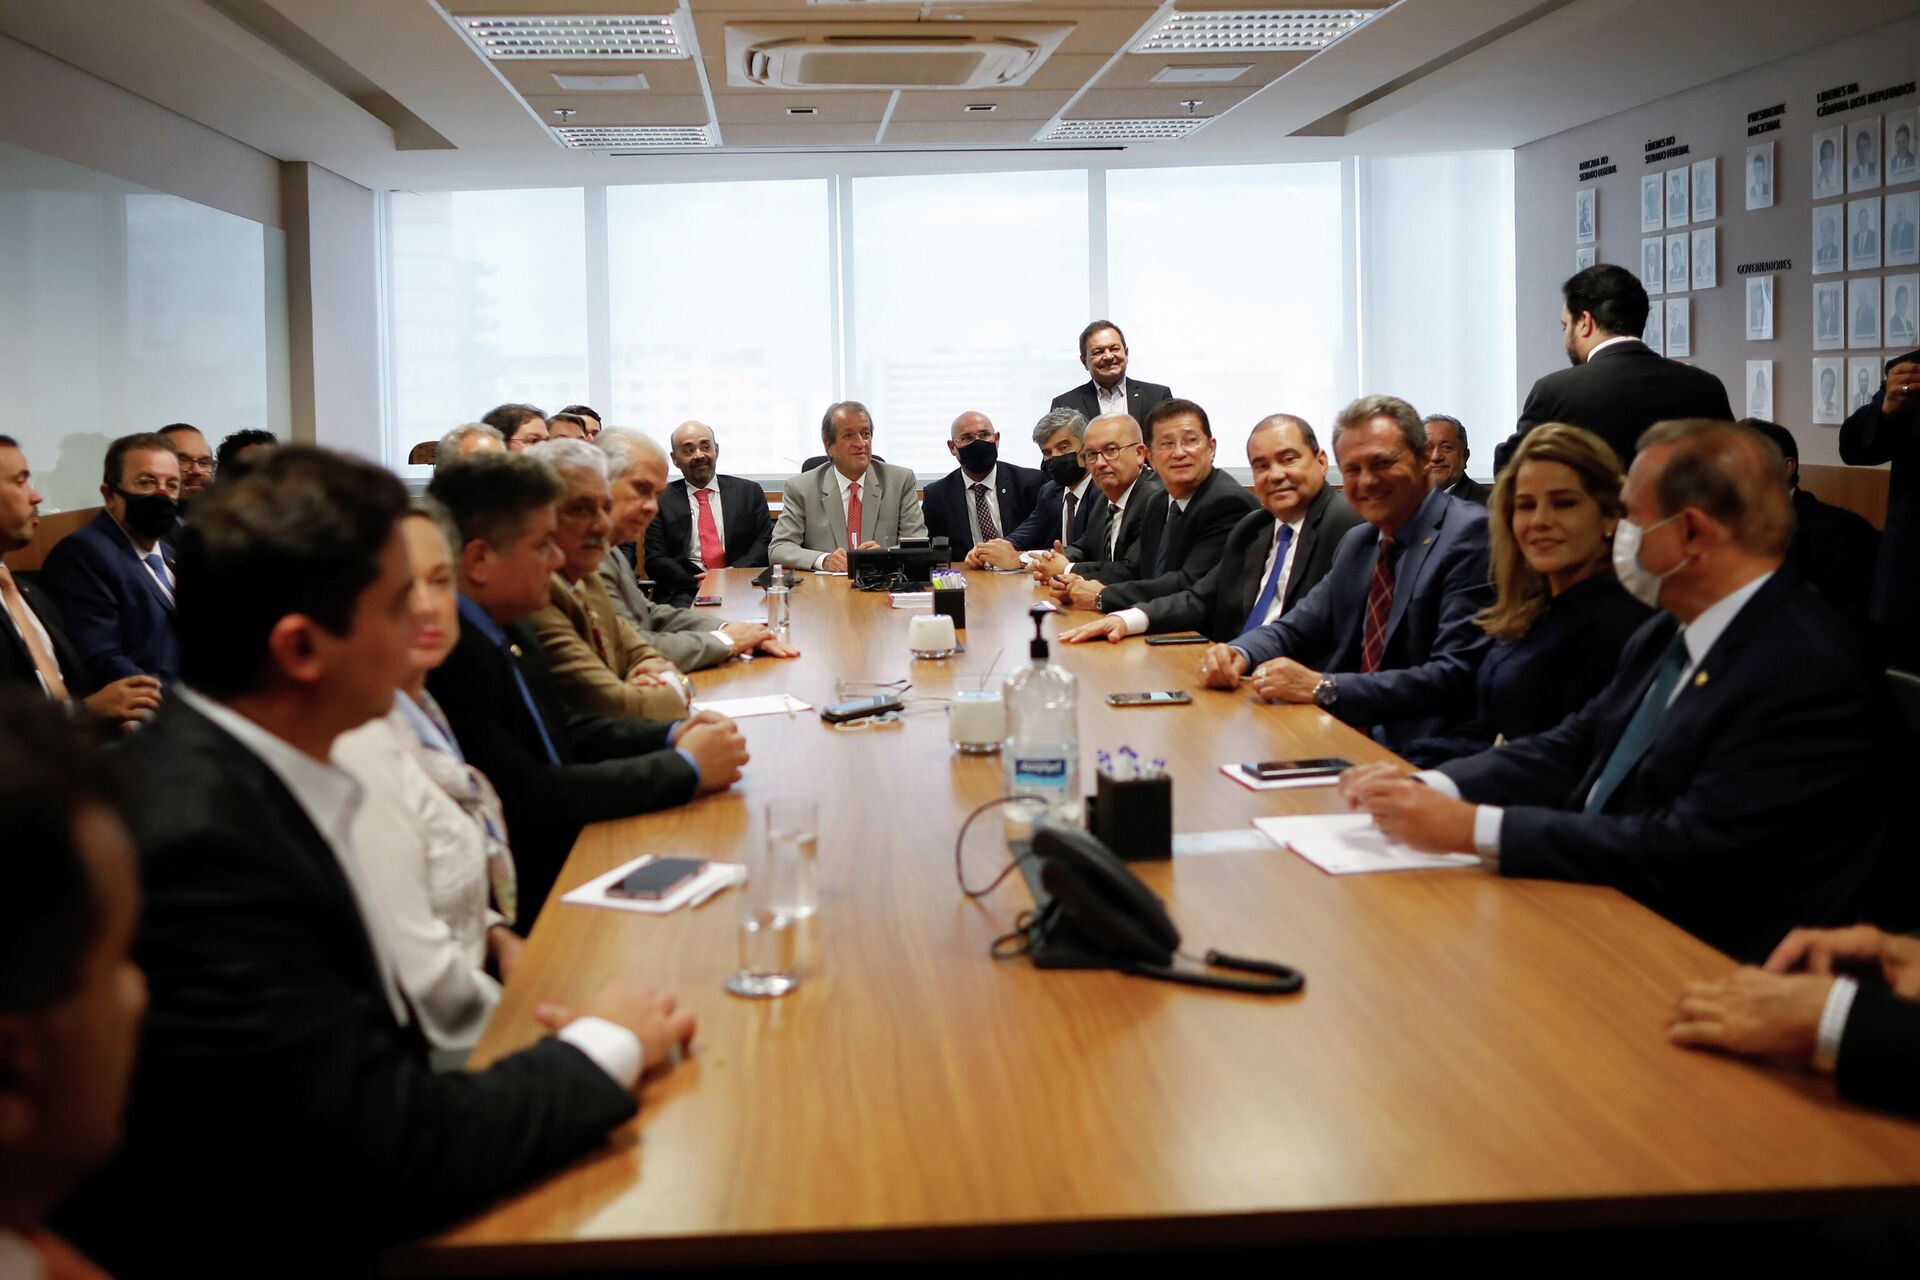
[426,450,747,933]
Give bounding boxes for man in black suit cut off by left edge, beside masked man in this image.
[0,436,159,725]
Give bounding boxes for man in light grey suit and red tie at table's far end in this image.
[770,399,927,574]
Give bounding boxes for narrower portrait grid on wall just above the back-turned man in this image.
[1640,155,1720,359]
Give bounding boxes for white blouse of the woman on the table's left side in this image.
[334,710,501,1052]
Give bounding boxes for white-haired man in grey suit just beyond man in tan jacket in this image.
[593,426,799,672]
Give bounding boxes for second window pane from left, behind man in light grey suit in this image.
[607,180,833,476]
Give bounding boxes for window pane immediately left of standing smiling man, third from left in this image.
[849,171,1087,474]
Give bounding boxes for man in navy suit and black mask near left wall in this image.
[40,434,180,687]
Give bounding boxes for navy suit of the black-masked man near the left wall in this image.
[40,510,180,689]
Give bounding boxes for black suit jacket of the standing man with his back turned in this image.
[1494,338,1734,472]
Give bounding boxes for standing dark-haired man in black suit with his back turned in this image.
[1494,263,1734,472]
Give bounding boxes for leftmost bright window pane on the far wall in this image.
[380,188,588,461]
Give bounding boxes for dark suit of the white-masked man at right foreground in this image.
[1440,566,1907,961]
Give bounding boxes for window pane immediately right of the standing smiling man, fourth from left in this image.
[1106,163,1354,450]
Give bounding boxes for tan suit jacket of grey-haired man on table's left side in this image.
[526,574,687,720]
